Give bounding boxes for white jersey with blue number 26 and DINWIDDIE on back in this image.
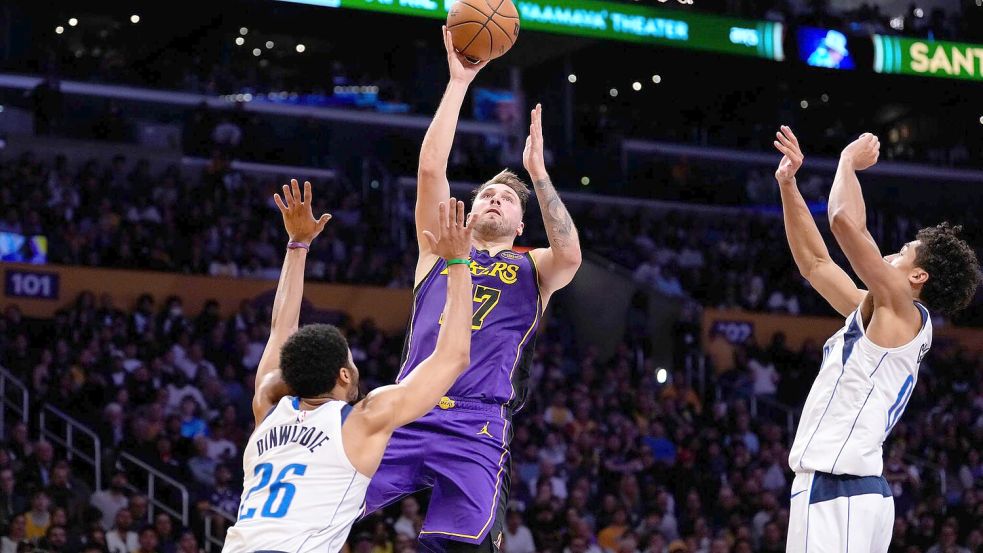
[222,396,369,553]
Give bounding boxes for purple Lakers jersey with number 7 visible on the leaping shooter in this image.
[396,247,542,412]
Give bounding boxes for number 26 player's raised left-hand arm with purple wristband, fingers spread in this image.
[253,180,331,424]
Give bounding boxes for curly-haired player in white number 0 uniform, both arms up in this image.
[775,127,980,553]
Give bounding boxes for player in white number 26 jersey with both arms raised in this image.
[223,181,480,553]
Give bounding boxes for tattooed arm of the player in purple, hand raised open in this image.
[522,104,582,305]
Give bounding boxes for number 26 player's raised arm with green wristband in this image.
[344,198,473,476]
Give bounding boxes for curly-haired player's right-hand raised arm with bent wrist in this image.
[829,133,918,315]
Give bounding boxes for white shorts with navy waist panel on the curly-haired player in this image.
[785,472,894,553]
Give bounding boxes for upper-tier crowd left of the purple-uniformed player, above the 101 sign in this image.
[0,154,412,287]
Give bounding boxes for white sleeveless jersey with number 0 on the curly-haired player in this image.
[789,302,932,476]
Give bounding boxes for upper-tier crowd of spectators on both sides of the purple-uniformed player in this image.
[0,149,983,324]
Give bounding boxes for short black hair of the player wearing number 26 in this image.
[280,324,348,398]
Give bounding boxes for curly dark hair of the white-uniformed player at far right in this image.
[915,222,980,313]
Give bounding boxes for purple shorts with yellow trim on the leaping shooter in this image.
[365,398,512,551]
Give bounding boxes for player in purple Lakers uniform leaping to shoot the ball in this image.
[366,29,581,551]
